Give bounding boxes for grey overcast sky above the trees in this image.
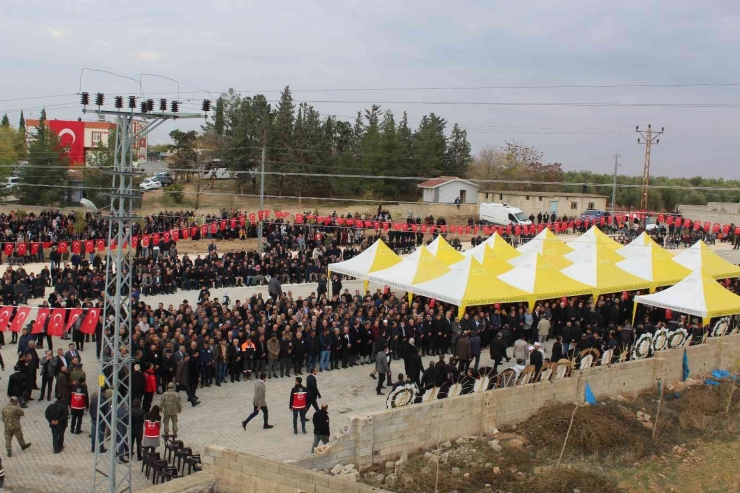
[0,0,740,179]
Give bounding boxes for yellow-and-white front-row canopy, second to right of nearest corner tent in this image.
[561,247,650,296]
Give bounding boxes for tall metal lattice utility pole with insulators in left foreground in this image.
[81,92,210,493]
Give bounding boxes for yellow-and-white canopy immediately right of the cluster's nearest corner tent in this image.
[498,252,594,306]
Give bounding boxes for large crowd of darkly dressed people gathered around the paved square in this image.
[0,207,740,476]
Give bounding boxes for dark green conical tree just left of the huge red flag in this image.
[18,110,69,206]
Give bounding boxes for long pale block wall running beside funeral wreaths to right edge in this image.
[297,335,740,470]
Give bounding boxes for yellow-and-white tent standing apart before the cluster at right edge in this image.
[635,269,740,323]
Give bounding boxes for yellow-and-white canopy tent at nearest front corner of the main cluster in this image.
[409,257,530,313]
